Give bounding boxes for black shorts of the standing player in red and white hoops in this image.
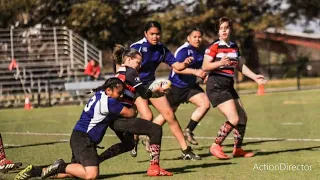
[206,74,239,107]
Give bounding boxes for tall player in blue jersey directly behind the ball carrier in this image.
[131,21,201,160]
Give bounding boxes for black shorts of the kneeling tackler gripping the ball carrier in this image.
[70,130,99,167]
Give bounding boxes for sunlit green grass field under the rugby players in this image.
[0,90,320,180]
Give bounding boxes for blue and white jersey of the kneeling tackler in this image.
[74,91,124,144]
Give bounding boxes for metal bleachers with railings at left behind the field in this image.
[0,27,102,108]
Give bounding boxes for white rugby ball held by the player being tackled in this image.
[149,79,172,98]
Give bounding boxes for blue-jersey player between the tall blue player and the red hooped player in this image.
[154,28,210,145]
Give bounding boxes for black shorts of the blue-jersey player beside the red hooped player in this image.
[166,84,204,107]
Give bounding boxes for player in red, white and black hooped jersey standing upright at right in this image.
[202,17,266,159]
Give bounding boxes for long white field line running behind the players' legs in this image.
[1,132,320,142]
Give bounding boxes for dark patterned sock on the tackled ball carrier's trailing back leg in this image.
[99,143,134,163]
